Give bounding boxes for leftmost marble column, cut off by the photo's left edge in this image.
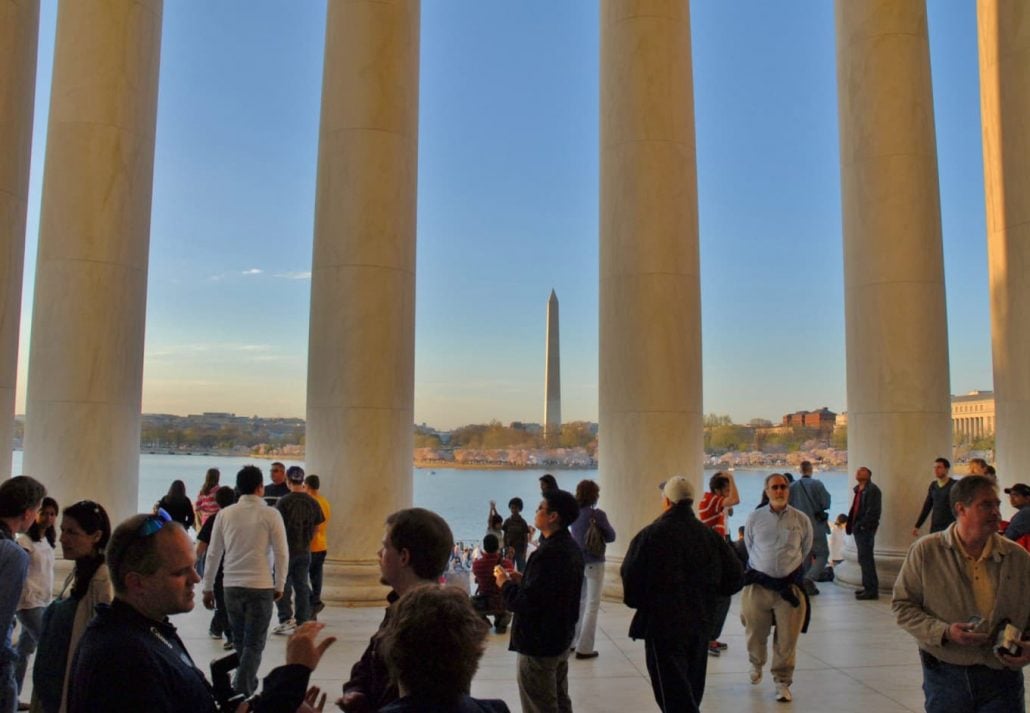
[0,0,39,480]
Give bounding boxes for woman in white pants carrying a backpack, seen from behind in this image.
[570,480,615,658]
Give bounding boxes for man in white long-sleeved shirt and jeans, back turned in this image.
[204,466,289,697]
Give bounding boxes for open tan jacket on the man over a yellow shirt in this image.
[891,524,1030,669]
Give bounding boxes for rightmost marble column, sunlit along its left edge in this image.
[976,0,1030,484]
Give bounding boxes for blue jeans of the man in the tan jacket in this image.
[919,650,1026,713]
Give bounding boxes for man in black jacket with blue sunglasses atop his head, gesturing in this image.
[68,514,335,713]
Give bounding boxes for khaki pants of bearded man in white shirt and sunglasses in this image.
[741,584,805,685]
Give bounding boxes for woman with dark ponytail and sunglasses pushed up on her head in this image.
[31,500,113,713]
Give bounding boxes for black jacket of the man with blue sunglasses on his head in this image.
[68,599,311,713]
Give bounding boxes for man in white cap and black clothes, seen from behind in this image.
[621,475,743,713]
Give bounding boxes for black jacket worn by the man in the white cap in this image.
[621,501,744,639]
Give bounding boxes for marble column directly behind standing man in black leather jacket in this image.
[836,0,951,588]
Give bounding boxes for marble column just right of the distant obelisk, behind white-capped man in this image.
[598,0,703,596]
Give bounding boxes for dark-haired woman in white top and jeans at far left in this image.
[14,498,60,693]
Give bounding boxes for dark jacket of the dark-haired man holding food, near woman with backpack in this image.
[501,529,583,656]
